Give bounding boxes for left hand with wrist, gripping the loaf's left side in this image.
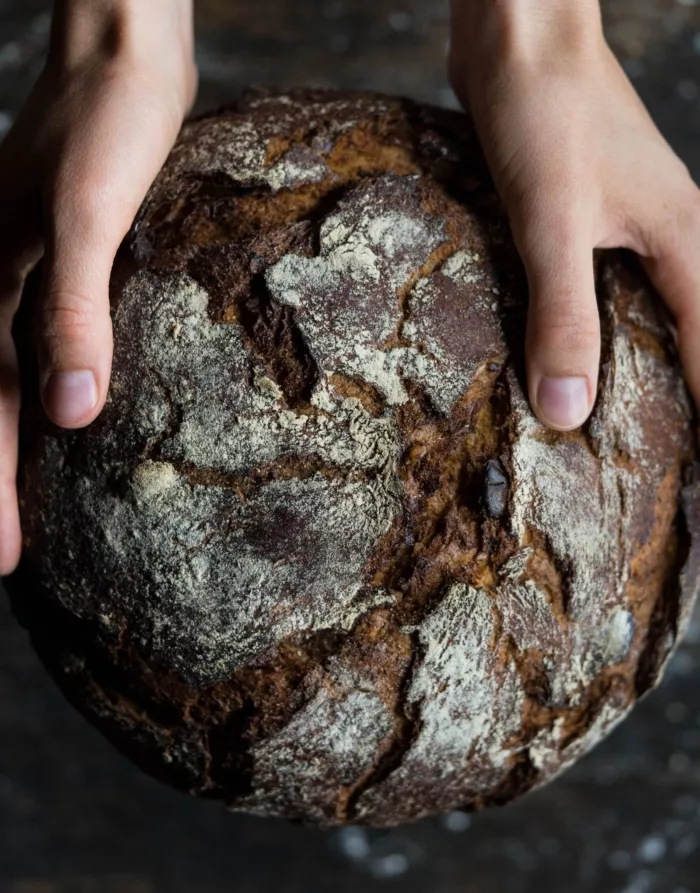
[0,0,197,575]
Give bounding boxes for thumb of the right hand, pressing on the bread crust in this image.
[514,201,600,431]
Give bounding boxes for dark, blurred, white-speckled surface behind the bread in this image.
[0,0,700,893]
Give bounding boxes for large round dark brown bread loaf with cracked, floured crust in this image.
[10,91,700,826]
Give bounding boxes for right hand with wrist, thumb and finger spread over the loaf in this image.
[450,0,700,430]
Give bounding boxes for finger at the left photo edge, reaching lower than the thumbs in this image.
[0,318,21,576]
